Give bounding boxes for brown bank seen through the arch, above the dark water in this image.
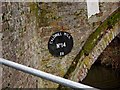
[97,33,120,69]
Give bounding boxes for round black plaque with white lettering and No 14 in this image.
[48,31,73,56]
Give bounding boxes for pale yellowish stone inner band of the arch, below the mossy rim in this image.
[70,23,120,82]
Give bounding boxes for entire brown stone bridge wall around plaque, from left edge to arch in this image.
[2,2,118,88]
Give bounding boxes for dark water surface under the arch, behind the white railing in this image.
[82,64,120,90]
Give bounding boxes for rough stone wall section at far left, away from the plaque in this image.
[2,2,39,88]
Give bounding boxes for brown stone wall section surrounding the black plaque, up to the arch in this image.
[38,2,118,88]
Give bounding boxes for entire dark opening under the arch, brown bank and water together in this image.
[80,34,120,90]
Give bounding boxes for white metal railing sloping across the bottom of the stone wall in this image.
[0,58,97,90]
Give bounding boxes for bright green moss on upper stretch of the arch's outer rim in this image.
[83,9,120,54]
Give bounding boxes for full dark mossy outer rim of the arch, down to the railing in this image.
[61,8,120,82]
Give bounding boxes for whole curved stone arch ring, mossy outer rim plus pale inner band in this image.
[64,8,120,82]
